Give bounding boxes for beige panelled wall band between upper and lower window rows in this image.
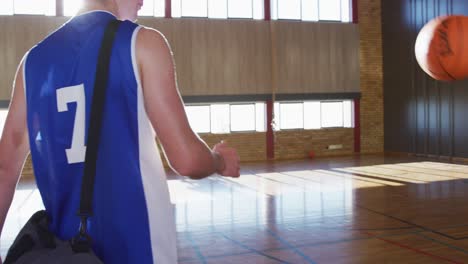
[0,16,359,100]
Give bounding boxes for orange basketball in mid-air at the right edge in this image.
[415,16,468,81]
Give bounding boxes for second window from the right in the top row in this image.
[171,0,264,19]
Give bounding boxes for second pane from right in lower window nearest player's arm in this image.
[231,104,255,132]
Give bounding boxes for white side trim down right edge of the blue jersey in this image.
[132,27,177,264]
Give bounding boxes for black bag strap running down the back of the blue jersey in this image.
[72,20,121,252]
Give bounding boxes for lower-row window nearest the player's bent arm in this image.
[185,102,266,134]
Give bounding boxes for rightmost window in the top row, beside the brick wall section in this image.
[271,0,351,23]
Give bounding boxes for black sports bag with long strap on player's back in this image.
[4,20,121,264]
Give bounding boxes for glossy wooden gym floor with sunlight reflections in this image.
[0,156,468,264]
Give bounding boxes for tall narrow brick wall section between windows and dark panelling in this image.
[358,0,384,153]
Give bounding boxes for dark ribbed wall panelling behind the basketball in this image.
[382,0,468,157]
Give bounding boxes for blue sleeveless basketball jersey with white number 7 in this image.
[24,11,177,264]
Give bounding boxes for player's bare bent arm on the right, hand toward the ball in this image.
[136,28,239,179]
